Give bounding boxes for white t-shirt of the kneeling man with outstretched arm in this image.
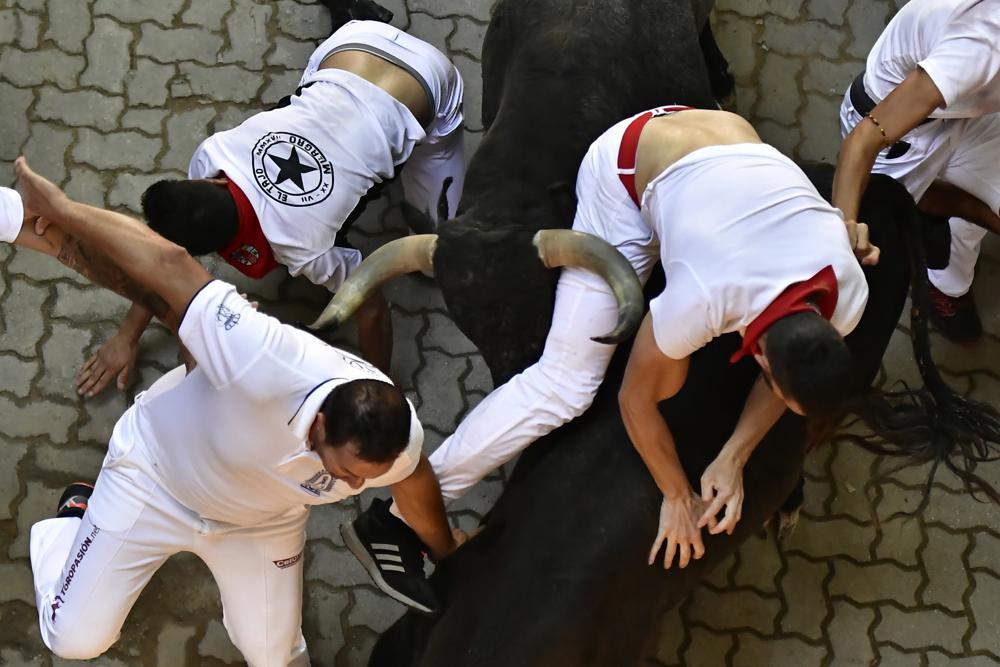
[112,281,423,526]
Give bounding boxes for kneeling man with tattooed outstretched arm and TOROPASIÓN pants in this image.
[16,158,455,667]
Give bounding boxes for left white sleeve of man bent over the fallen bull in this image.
[649,262,718,360]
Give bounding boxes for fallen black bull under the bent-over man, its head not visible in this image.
[370,170,913,667]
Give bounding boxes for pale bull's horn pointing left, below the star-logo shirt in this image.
[309,234,437,330]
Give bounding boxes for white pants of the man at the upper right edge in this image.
[840,92,1000,297]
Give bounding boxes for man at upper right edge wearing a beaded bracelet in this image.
[833,0,1000,343]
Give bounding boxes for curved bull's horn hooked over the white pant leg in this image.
[532,229,645,345]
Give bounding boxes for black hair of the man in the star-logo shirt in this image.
[142,181,239,255]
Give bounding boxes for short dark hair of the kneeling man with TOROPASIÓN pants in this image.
[320,380,410,463]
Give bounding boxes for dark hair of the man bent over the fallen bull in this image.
[766,311,853,417]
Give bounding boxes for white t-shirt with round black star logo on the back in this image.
[188,69,425,291]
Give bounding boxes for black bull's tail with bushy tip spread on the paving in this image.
[851,206,1000,509]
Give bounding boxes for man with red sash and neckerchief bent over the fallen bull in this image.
[342,107,874,590]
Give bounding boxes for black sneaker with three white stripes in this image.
[340,498,441,616]
